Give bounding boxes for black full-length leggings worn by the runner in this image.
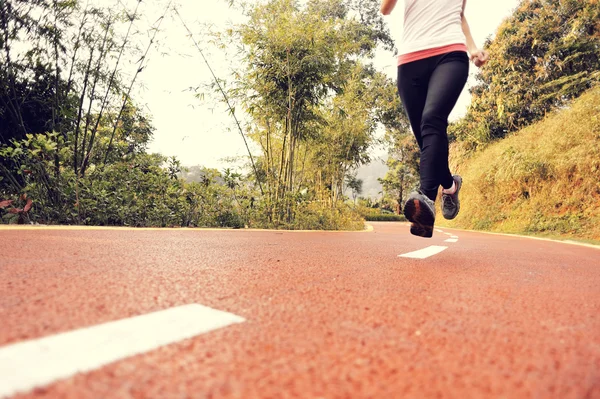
[398,51,469,201]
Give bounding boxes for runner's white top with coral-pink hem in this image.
[399,0,466,55]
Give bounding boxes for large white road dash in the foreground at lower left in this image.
[0,304,245,398]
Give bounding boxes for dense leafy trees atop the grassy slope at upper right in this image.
[450,0,600,148]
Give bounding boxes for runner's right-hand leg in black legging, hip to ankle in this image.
[418,52,469,201]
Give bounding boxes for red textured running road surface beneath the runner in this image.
[0,223,600,399]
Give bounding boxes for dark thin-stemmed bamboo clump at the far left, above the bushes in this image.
[0,0,169,225]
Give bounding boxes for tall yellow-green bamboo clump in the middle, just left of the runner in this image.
[230,0,404,222]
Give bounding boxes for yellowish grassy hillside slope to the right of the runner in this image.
[440,88,600,240]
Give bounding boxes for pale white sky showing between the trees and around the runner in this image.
[124,0,519,169]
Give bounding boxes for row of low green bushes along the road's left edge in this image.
[0,134,376,230]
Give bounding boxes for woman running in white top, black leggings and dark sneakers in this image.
[381,0,489,237]
